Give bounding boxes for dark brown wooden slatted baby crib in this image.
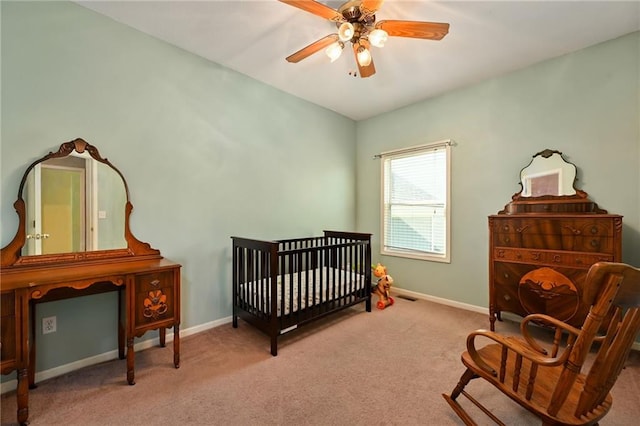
[231,231,371,356]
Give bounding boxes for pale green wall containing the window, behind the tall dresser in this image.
[357,33,640,307]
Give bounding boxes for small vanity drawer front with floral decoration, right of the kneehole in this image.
[134,271,177,329]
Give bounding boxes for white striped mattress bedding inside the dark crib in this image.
[240,267,365,316]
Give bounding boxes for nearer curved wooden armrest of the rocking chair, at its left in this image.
[467,330,571,376]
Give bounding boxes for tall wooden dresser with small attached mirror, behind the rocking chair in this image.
[489,150,622,330]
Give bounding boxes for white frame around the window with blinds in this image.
[378,140,452,263]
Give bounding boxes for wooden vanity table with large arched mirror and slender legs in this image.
[0,139,181,424]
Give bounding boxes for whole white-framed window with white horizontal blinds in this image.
[380,141,451,262]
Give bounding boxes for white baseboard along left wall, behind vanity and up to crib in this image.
[0,317,231,394]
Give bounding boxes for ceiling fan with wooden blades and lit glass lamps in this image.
[279,0,449,78]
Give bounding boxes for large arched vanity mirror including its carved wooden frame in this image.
[1,139,158,266]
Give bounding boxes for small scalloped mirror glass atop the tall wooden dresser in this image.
[520,149,576,197]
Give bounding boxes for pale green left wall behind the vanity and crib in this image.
[0,1,356,372]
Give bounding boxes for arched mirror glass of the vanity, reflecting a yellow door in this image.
[23,150,127,256]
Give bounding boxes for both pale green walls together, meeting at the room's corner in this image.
[0,1,640,380]
